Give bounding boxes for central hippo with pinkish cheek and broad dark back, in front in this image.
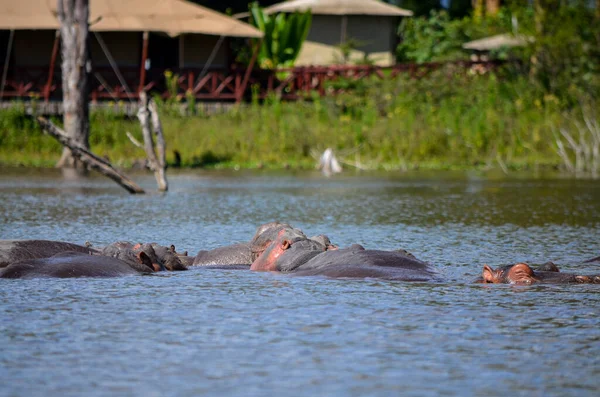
[250,229,436,281]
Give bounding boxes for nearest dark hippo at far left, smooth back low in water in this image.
[0,251,165,279]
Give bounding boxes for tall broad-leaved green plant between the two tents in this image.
[250,2,312,69]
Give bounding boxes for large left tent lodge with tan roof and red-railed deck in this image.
[0,0,262,101]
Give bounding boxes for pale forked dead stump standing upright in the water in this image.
[137,91,169,192]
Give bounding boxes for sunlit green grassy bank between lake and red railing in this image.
[0,66,599,169]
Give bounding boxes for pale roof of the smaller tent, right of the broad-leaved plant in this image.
[258,0,413,17]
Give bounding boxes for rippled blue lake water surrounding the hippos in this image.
[0,169,600,397]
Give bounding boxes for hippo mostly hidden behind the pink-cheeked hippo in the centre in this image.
[192,222,335,269]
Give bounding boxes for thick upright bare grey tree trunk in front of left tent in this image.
[57,0,91,169]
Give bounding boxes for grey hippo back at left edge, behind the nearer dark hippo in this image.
[0,240,98,268]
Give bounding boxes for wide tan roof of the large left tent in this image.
[0,0,262,37]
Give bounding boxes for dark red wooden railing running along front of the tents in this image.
[0,61,500,101]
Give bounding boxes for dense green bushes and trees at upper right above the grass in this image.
[397,0,600,101]
